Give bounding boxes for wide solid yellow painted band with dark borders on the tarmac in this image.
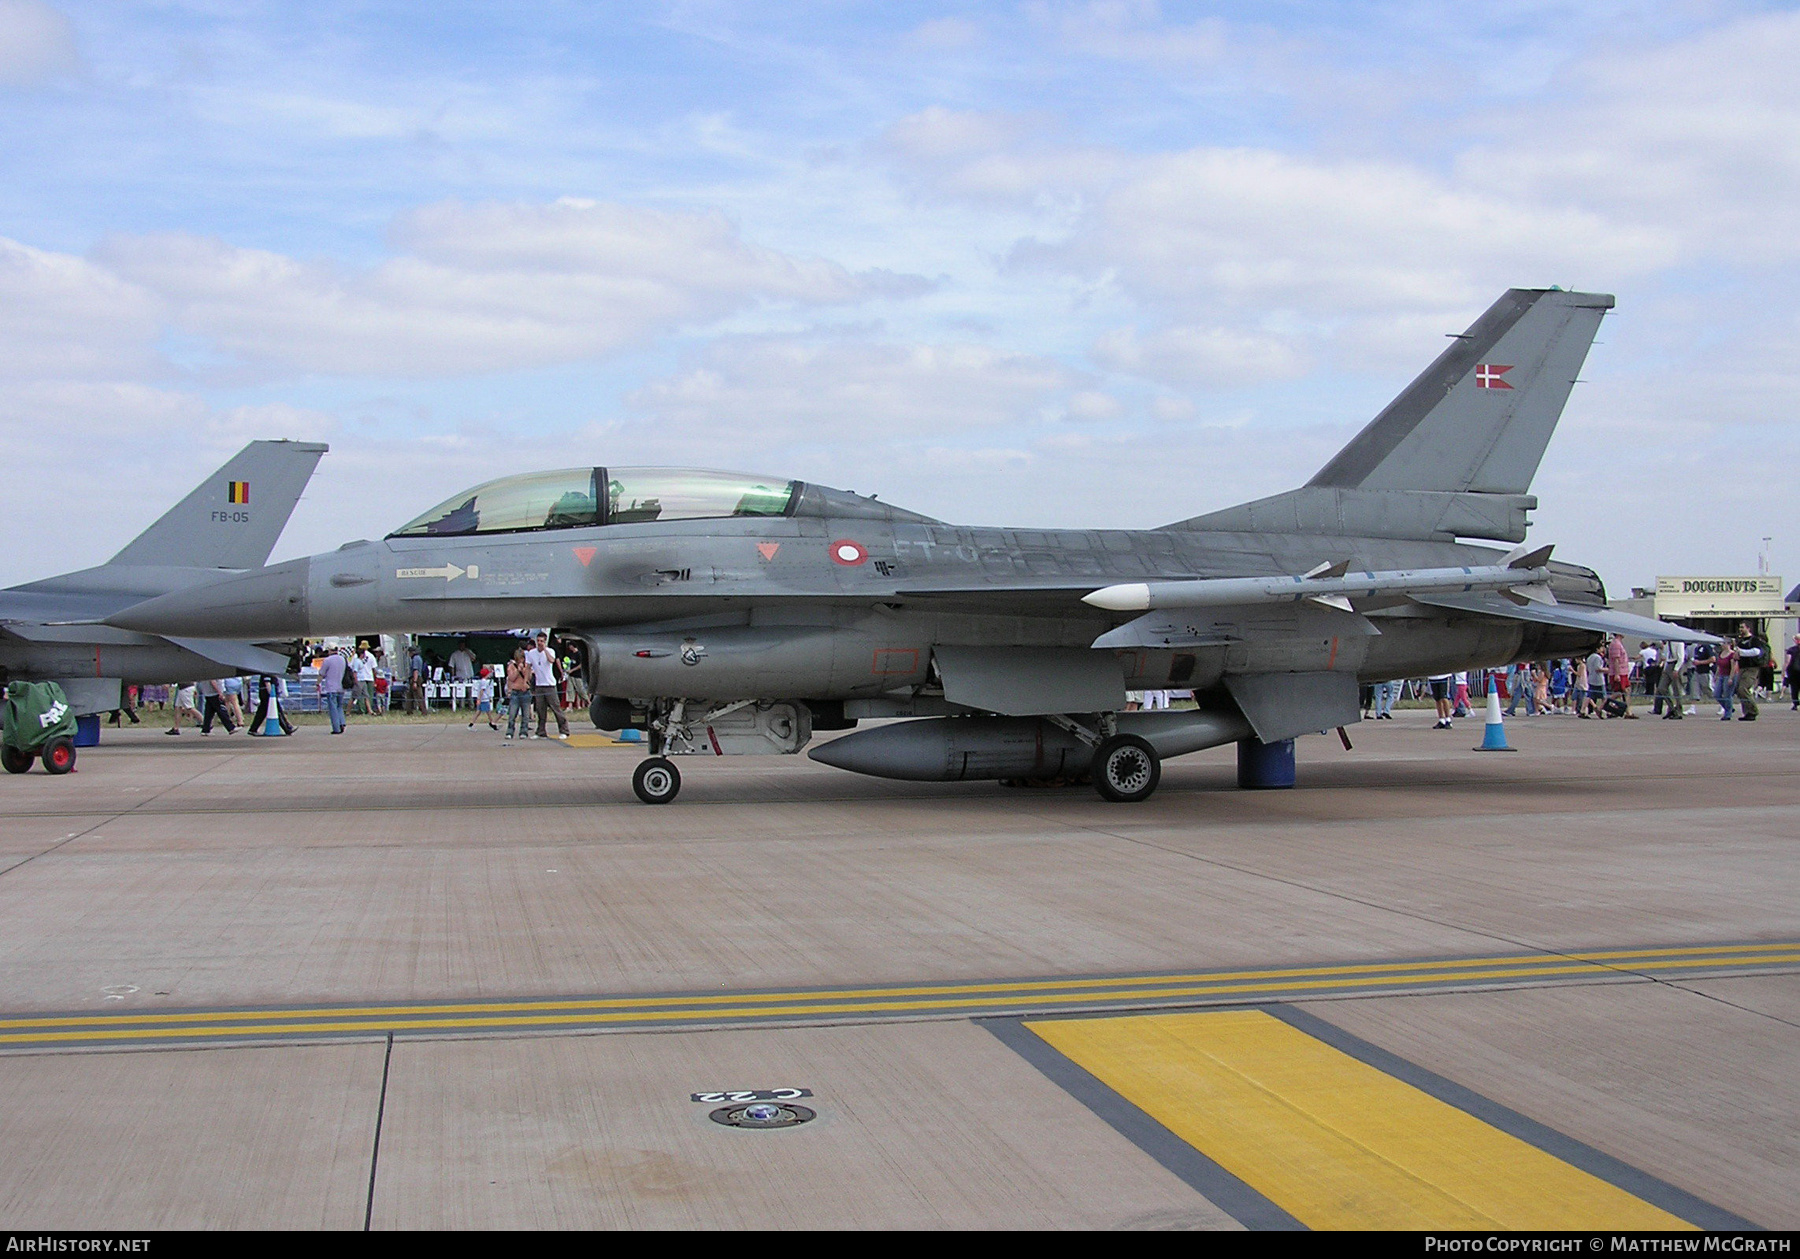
[1026,1010,1692,1230]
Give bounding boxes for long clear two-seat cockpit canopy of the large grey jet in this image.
[389,468,801,539]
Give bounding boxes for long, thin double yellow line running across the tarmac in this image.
[0,949,1800,1045]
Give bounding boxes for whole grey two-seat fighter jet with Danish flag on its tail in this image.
[110,288,1713,803]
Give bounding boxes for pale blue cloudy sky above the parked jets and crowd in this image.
[0,0,1800,593]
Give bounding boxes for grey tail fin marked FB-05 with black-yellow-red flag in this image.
[106,441,329,569]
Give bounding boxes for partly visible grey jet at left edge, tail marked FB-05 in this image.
[0,441,328,715]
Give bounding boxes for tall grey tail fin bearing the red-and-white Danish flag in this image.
[1175,288,1613,542]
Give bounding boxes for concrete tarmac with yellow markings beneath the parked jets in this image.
[0,704,1800,1228]
